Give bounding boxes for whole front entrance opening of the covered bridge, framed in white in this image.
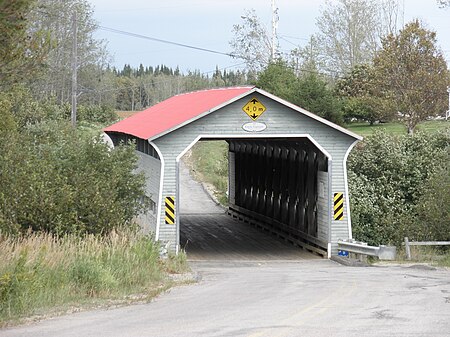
[178,137,330,259]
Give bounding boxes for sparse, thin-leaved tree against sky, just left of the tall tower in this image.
[230,9,272,73]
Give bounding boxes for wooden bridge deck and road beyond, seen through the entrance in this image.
[180,162,314,261]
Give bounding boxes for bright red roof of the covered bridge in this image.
[103,87,254,139]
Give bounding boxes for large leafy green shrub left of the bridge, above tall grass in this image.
[0,121,146,234]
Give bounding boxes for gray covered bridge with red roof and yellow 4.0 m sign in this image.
[104,87,362,256]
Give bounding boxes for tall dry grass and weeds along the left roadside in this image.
[0,231,192,327]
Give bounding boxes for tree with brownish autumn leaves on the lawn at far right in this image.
[374,20,449,133]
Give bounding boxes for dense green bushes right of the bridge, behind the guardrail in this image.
[348,130,450,245]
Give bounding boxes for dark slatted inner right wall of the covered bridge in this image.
[228,138,328,251]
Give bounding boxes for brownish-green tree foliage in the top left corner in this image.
[0,0,48,89]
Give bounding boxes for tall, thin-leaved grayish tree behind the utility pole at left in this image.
[30,0,108,104]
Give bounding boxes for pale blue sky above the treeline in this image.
[90,0,450,74]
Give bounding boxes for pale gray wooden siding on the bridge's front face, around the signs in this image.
[154,93,355,250]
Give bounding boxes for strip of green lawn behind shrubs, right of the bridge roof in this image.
[345,120,450,137]
